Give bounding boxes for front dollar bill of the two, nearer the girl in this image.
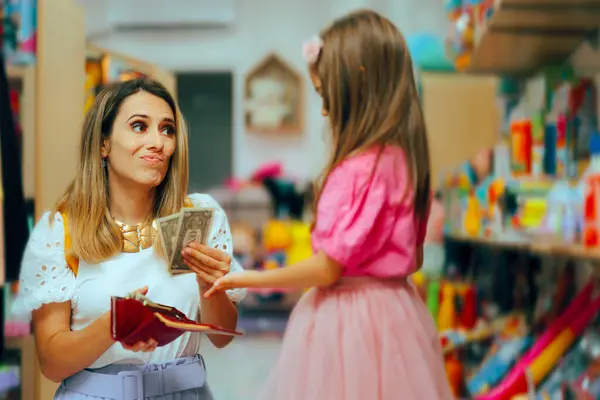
[169,208,215,275]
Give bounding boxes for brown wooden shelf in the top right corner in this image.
[468,0,600,74]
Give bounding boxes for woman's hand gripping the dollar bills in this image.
[181,242,231,287]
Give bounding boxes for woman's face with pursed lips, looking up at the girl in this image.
[101,91,177,188]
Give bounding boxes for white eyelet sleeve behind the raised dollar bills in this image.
[188,193,247,303]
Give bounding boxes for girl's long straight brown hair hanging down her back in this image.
[310,10,430,218]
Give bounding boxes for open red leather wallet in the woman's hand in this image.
[110,297,243,347]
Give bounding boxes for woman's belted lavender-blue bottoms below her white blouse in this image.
[62,356,206,400]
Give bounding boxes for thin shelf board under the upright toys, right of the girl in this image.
[447,234,600,263]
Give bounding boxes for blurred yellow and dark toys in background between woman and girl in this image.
[216,162,313,310]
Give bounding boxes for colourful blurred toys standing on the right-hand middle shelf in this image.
[441,67,600,248]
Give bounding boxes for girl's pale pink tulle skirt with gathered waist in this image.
[260,278,453,400]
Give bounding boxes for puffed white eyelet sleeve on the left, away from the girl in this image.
[12,212,75,319]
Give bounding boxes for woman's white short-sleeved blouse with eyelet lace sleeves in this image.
[12,194,246,368]
